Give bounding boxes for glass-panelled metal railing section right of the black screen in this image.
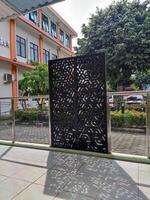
[107,91,150,157]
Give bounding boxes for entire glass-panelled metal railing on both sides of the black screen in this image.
[0,91,150,157]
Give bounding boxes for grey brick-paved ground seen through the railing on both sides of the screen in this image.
[0,124,146,156]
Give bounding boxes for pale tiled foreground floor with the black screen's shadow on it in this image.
[0,145,150,200]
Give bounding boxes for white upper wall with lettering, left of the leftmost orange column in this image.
[0,21,10,58]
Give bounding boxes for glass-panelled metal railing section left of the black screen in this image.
[0,96,51,146]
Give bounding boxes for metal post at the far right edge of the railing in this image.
[146,93,150,158]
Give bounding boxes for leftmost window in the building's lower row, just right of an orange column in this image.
[16,35,26,58]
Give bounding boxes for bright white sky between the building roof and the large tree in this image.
[52,0,116,46]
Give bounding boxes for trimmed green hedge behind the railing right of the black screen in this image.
[111,111,146,128]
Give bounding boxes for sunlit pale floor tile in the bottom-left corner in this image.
[0,178,29,199]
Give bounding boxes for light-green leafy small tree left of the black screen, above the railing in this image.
[19,64,48,95]
